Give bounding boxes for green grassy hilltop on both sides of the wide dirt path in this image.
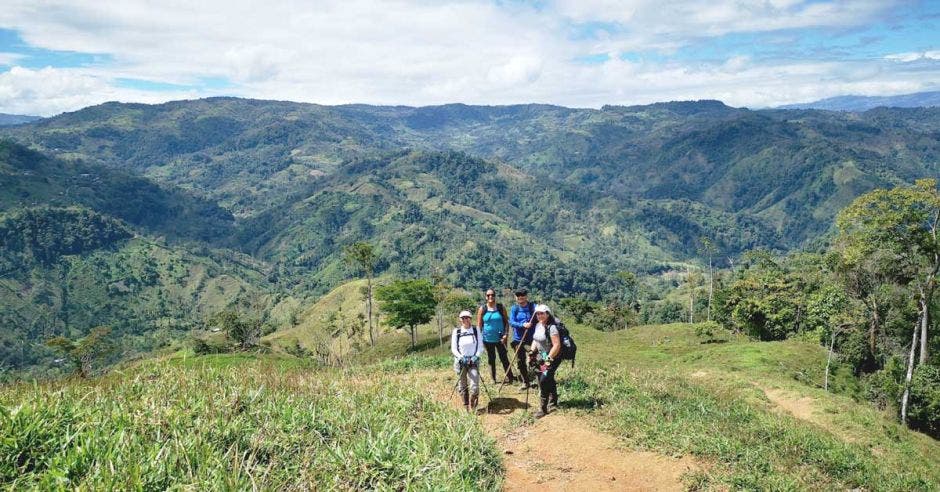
[0,318,940,491]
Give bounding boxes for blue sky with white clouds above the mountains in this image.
[0,0,940,116]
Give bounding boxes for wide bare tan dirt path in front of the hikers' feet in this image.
[436,374,700,492]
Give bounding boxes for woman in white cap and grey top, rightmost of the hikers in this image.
[529,304,562,418]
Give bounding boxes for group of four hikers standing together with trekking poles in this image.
[450,289,575,418]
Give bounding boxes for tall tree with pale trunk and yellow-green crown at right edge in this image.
[836,179,940,424]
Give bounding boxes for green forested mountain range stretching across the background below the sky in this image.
[0,98,940,376]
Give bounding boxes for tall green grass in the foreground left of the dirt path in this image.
[0,358,502,490]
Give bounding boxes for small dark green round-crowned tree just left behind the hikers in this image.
[375,279,437,350]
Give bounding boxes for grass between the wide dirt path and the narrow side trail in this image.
[561,367,940,491]
